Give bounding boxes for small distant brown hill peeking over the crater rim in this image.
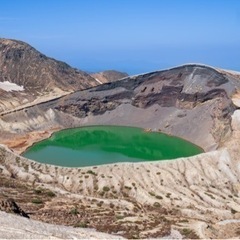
[91,70,128,83]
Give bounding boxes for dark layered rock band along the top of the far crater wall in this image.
[56,65,234,114]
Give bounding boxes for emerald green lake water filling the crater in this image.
[23,126,203,167]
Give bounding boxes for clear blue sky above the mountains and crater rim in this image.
[0,0,240,74]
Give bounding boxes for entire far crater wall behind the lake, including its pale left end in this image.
[0,62,240,151]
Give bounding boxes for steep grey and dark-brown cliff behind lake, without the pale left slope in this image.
[53,65,239,150]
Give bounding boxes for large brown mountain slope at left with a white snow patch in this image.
[0,39,99,112]
